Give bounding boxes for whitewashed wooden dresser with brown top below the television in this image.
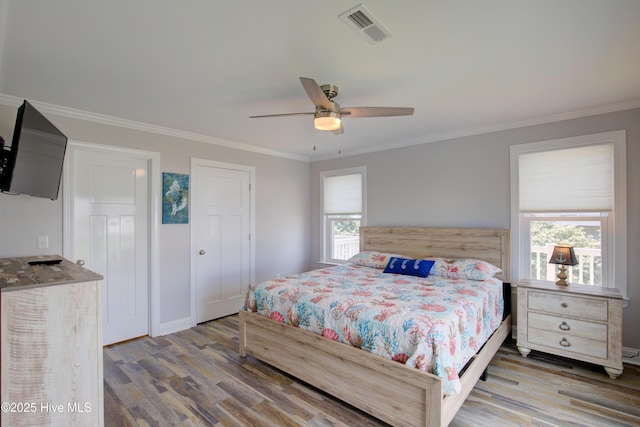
[0,256,104,427]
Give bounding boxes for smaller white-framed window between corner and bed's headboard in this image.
[320,167,366,263]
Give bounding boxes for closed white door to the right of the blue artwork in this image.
[192,164,251,323]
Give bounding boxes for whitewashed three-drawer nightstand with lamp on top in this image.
[516,280,622,378]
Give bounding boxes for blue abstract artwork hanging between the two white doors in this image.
[162,172,189,224]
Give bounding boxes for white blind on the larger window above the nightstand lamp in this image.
[518,144,614,212]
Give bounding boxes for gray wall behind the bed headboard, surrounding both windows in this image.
[311,109,640,349]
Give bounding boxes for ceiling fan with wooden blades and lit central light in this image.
[249,77,413,135]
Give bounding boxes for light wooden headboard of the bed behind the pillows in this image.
[360,227,511,282]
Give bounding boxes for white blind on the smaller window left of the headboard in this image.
[324,173,362,215]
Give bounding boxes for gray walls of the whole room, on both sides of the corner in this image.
[0,99,640,348]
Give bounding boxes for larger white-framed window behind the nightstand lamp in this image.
[511,131,627,297]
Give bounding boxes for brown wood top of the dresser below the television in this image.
[0,255,102,292]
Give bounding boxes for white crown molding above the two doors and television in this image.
[0,94,311,162]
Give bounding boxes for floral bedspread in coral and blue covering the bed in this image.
[245,264,503,394]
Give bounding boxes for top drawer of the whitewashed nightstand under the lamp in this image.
[527,291,609,322]
